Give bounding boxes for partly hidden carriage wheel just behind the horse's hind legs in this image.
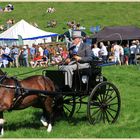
[63,95,76,118]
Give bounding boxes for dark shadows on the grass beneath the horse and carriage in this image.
[5,109,88,131]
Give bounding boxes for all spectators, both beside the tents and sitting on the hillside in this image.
[0,7,140,68]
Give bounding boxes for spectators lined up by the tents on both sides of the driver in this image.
[0,37,140,68]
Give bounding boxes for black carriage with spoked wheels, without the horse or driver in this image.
[43,61,121,124]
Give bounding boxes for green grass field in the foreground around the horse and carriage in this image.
[3,66,140,138]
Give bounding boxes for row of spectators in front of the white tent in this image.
[0,44,68,68]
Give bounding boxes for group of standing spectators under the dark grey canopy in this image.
[92,40,140,65]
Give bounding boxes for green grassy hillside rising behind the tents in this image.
[0,2,140,34]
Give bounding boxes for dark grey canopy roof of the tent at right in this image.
[94,26,140,42]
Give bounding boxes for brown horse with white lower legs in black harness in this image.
[0,73,55,135]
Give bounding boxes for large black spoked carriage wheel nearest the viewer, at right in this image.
[87,81,121,124]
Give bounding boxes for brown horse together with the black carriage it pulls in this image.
[0,61,121,135]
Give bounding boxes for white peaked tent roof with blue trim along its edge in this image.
[0,19,58,45]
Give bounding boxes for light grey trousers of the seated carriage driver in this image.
[59,62,90,88]
